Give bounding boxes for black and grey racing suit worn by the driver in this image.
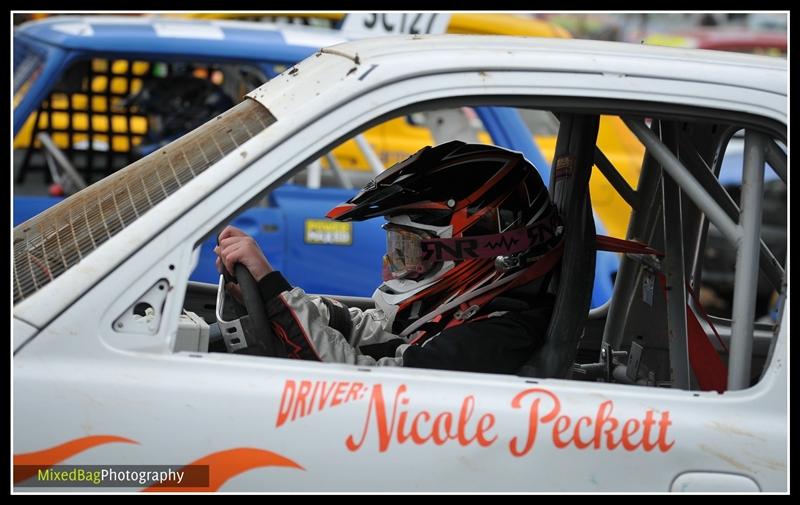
[259,271,552,373]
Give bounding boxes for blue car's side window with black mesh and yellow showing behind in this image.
[14,57,266,194]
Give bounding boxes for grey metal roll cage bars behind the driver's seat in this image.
[590,116,787,390]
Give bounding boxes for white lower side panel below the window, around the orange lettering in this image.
[14,314,786,491]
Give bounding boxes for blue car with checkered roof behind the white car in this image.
[13,16,617,307]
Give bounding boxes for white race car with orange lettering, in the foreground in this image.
[12,35,789,492]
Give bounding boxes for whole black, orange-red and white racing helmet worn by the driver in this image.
[327,141,563,330]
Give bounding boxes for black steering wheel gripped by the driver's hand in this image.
[222,263,288,358]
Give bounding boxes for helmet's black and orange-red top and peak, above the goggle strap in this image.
[327,140,556,243]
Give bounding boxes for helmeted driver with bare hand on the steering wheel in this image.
[215,141,563,373]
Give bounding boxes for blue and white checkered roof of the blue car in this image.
[15,16,347,61]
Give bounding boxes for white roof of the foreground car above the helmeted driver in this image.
[256,35,788,124]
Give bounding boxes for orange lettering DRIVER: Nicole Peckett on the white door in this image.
[275,380,675,457]
